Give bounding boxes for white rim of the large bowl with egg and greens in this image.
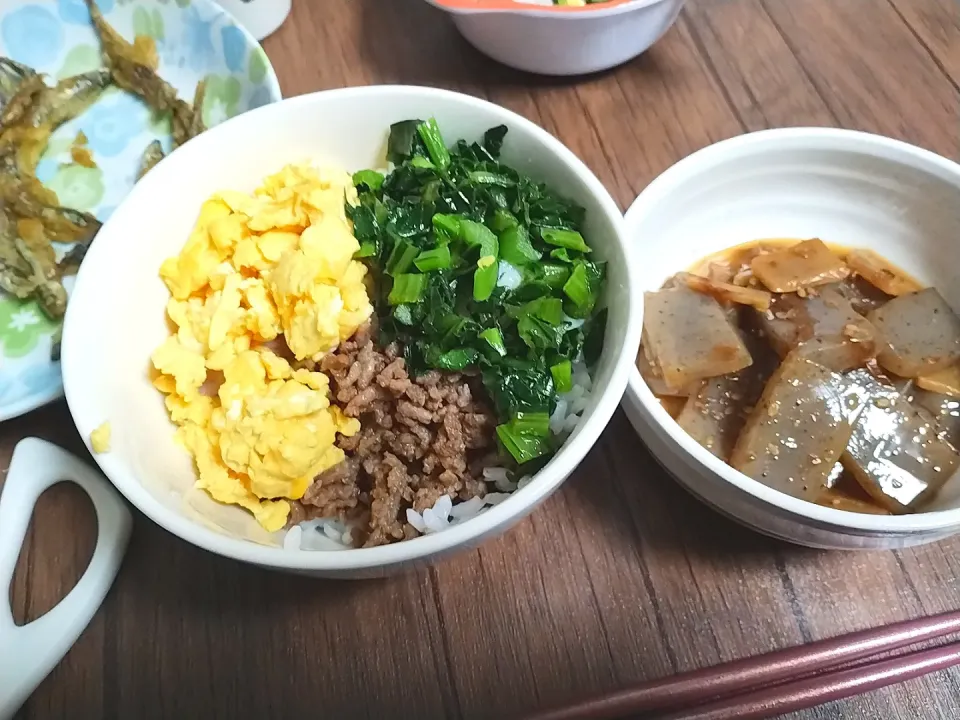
[62,85,641,571]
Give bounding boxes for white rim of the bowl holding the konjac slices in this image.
[624,127,960,534]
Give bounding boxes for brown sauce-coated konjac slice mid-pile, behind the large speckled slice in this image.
[759,285,877,372]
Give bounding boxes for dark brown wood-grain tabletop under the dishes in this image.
[0,0,960,720]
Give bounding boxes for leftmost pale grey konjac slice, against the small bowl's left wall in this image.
[643,286,752,388]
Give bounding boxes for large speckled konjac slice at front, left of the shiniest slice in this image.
[730,352,863,502]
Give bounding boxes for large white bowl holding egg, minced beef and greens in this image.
[63,86,640,577]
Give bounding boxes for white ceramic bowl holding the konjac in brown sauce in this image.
[624,128,960,548]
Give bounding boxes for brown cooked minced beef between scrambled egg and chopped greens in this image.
[291,328,498,547]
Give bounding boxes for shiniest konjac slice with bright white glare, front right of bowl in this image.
[841,370,960,513]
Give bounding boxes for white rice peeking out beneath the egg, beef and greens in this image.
[283,360,593,552]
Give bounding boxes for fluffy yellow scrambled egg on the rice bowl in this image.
[153,166,373,532]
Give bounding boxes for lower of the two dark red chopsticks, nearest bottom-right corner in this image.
[661,642,960,720]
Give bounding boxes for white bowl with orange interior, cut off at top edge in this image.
[427,0,684,75]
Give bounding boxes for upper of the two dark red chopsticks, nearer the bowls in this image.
[527,612,960,720]
